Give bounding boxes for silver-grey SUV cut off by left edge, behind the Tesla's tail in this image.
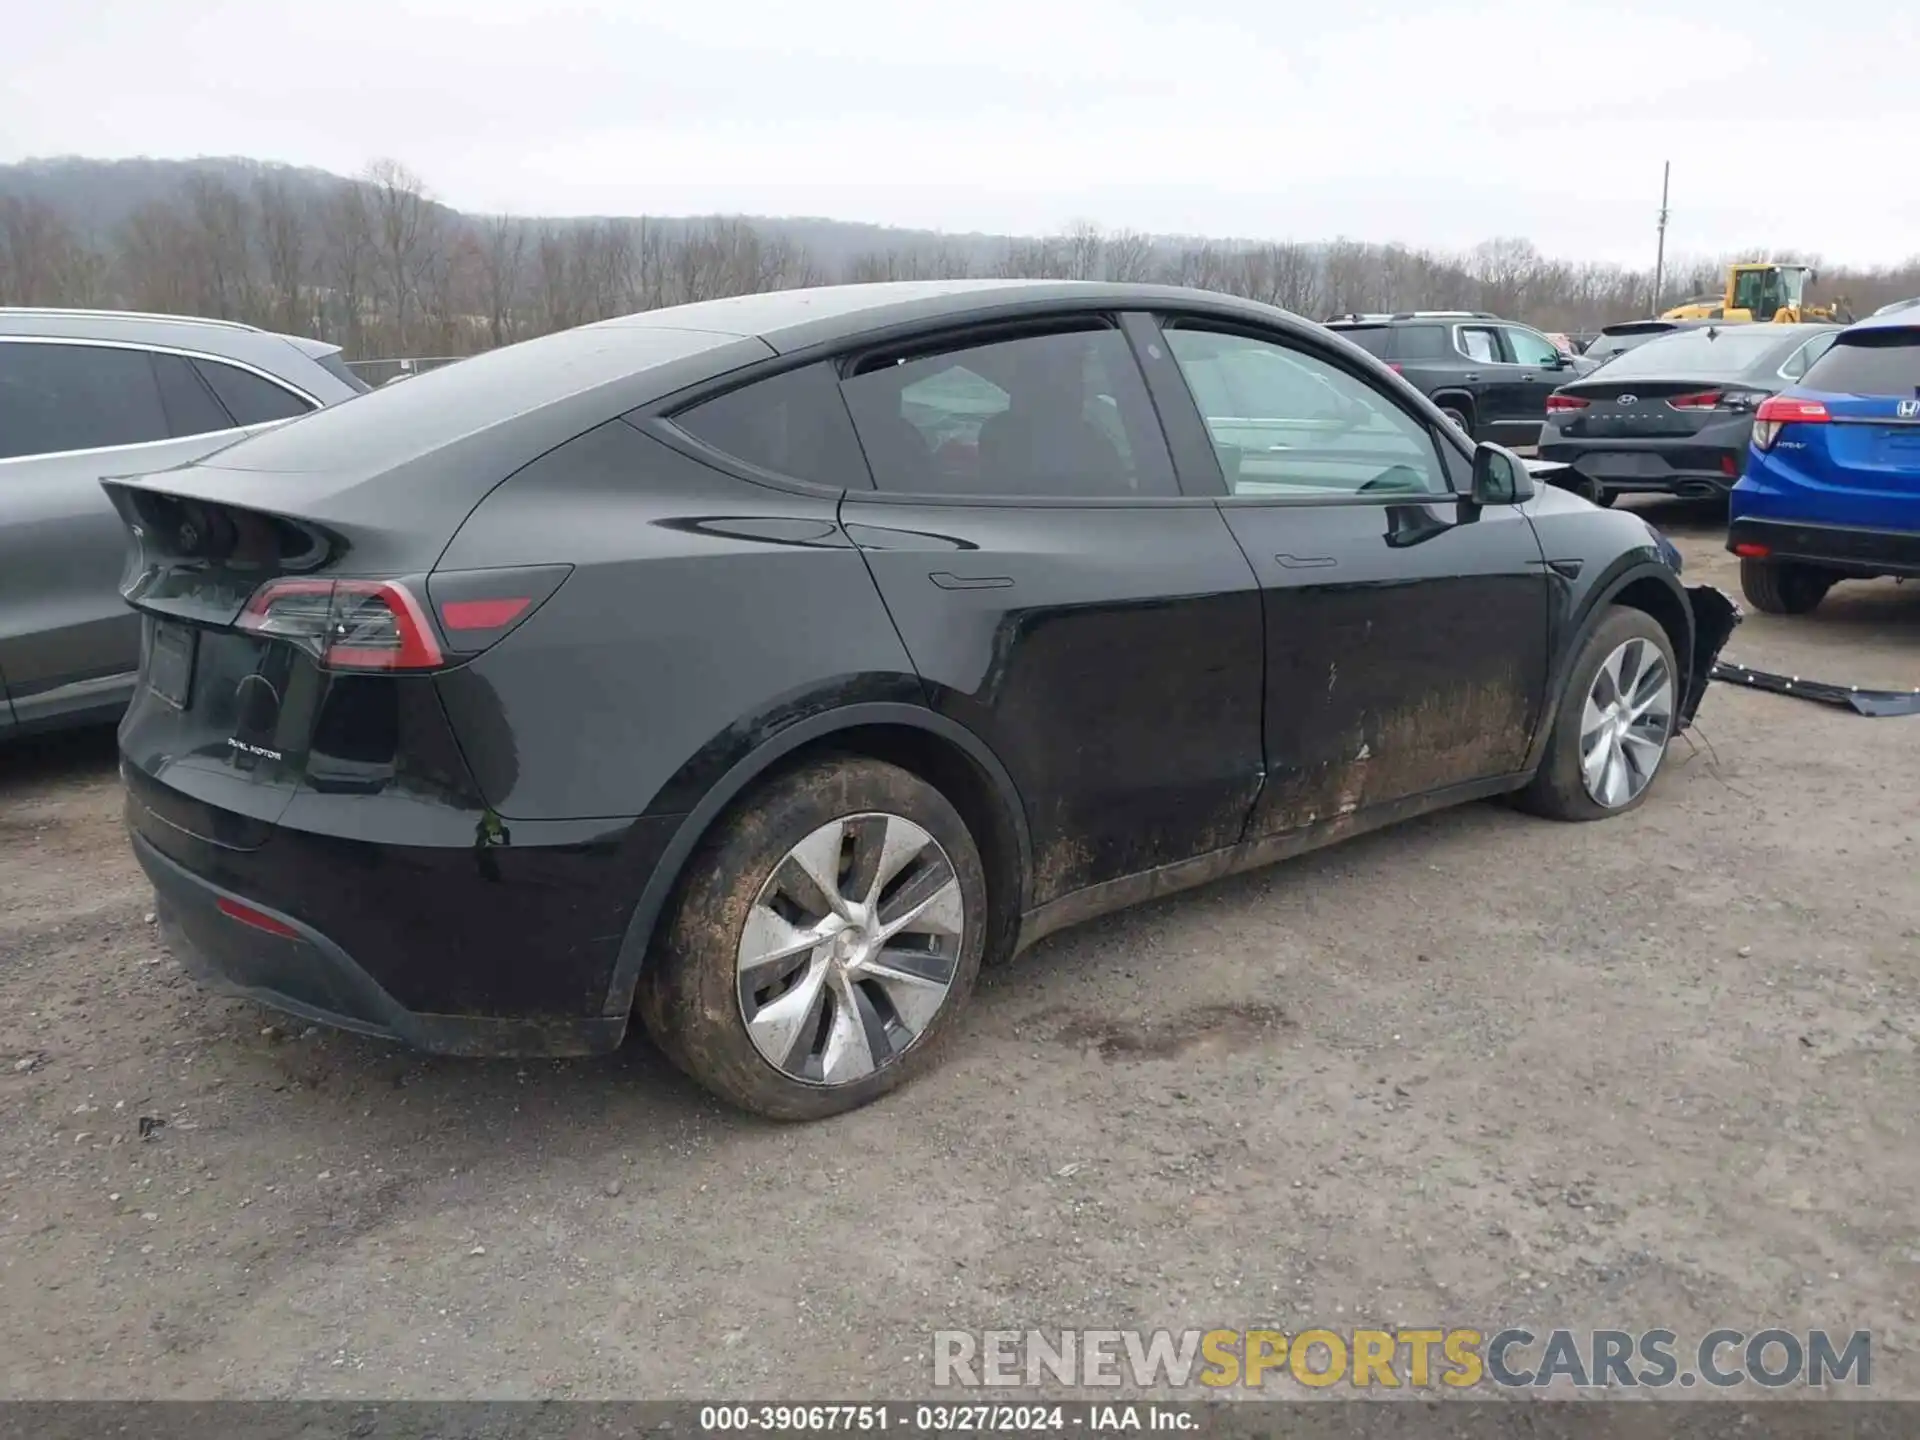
[0,307,367,737]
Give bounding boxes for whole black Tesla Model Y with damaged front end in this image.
[108,282,1736,1117]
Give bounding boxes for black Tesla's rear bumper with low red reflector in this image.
[123,766,678,1056]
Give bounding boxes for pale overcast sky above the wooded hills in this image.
[0,0,1920,265]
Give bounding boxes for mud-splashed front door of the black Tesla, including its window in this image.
[1146,315,1548,837]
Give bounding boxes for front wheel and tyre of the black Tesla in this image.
[1515,605,1680,820]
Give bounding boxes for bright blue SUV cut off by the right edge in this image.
[1726,307,1920,614]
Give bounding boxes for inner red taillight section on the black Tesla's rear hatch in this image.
[238,580,445,670]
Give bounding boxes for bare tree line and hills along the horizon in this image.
[0,159,1920,359]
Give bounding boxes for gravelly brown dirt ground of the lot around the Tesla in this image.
[0,507,1920,1398]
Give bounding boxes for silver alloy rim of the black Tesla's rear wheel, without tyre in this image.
[737,812,966,1085]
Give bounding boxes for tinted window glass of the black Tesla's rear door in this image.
[843,328,1179,499]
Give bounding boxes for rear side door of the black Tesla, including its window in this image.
[841,315,1261,904]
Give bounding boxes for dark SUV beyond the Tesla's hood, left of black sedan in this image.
[1327,309,1594,445]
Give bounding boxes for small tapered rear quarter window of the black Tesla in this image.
[674,365,868,490]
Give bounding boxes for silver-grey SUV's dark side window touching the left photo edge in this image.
[0,342,169,459]
